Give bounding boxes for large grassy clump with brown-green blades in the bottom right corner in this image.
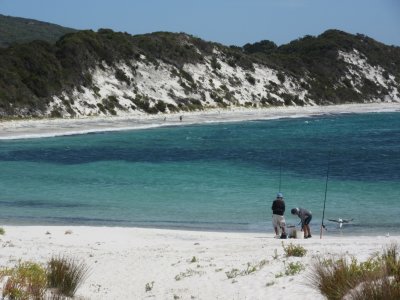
[309,245,400,300]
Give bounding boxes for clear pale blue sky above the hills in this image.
[0,0,400,46]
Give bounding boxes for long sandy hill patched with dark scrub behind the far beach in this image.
[0,15,400,118]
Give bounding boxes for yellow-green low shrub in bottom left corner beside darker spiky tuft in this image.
[0,262,47,299]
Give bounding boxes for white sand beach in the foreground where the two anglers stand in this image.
[0,226,400,300]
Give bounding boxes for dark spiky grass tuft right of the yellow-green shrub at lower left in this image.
[47,256,89,297]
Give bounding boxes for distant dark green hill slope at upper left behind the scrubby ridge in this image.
[0,14,76,47]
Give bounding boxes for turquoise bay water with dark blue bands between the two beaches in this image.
[0,112,400,234]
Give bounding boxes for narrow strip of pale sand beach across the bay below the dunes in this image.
[0,103,400,139]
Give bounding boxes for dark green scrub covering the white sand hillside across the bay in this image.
[0,24,400,118]
